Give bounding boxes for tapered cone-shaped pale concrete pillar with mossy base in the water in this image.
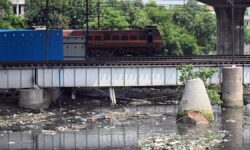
[177,78,214,121]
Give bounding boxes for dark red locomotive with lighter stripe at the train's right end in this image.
[63,26,163,57]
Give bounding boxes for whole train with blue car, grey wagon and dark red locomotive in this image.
[0,26,163,61]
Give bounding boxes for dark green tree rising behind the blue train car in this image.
[25,0,76,28]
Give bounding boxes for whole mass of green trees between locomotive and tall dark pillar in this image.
[142,0,216,55]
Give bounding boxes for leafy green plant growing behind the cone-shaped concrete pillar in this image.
[178,65,222,105]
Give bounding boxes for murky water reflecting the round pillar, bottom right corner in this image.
[215,108,250,150]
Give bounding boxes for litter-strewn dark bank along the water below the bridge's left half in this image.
[0,93,172,132]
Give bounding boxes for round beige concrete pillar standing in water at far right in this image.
[222,67,243,107]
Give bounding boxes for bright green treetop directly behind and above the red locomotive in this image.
[90,0,144,28]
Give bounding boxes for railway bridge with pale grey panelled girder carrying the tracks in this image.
[0,56,250,107]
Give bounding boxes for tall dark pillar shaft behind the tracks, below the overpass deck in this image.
[214,6,246,55]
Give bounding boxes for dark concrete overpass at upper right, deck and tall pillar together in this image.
[197,0,250,55]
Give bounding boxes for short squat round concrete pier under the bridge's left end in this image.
[18,89,50,109]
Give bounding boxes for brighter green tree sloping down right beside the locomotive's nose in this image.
[144,1,200,55]
